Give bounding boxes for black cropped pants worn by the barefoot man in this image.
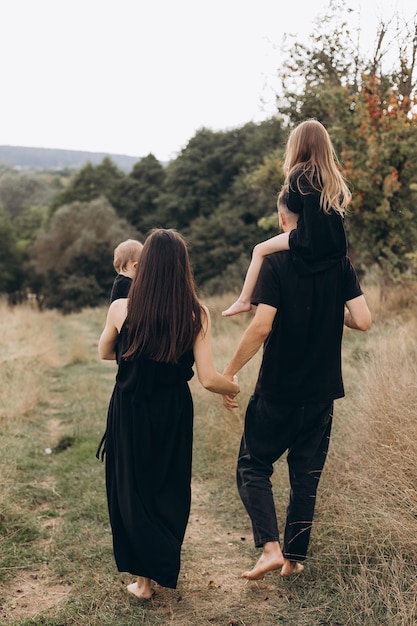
[236,395,333,561]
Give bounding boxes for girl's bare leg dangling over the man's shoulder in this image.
[222,233,289,317]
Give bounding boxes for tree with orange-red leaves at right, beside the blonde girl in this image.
[344,69,417,282]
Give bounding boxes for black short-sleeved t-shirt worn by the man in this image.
[252,251,362,404]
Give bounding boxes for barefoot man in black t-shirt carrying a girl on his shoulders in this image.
[223,190,371,580]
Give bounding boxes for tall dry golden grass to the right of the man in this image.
[308,304,417,626]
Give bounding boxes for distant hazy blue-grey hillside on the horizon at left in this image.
[0,146,140,172]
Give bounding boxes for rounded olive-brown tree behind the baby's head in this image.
[29,198,136,313]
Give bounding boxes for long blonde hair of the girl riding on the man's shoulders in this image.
[284,120,352,216]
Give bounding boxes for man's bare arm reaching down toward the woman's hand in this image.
[223,304,277,388]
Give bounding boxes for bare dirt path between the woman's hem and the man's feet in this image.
[135,481,291,626]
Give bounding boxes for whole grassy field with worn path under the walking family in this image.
[0,288,417,626]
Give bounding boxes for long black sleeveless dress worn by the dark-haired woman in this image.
[98,326,194,588]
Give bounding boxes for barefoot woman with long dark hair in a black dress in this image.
[98,229,239,598]
